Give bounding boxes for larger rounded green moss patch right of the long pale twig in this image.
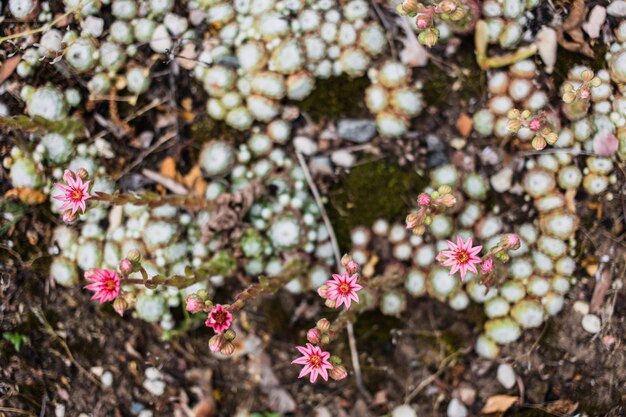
[328,161,427,251]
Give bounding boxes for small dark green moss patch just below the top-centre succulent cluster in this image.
[297,75,370,119]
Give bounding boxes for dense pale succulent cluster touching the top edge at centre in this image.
[194,0,387,130]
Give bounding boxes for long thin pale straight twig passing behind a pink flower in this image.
[296,152,372,401]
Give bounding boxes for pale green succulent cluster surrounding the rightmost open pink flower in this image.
[344,162,578,358]
